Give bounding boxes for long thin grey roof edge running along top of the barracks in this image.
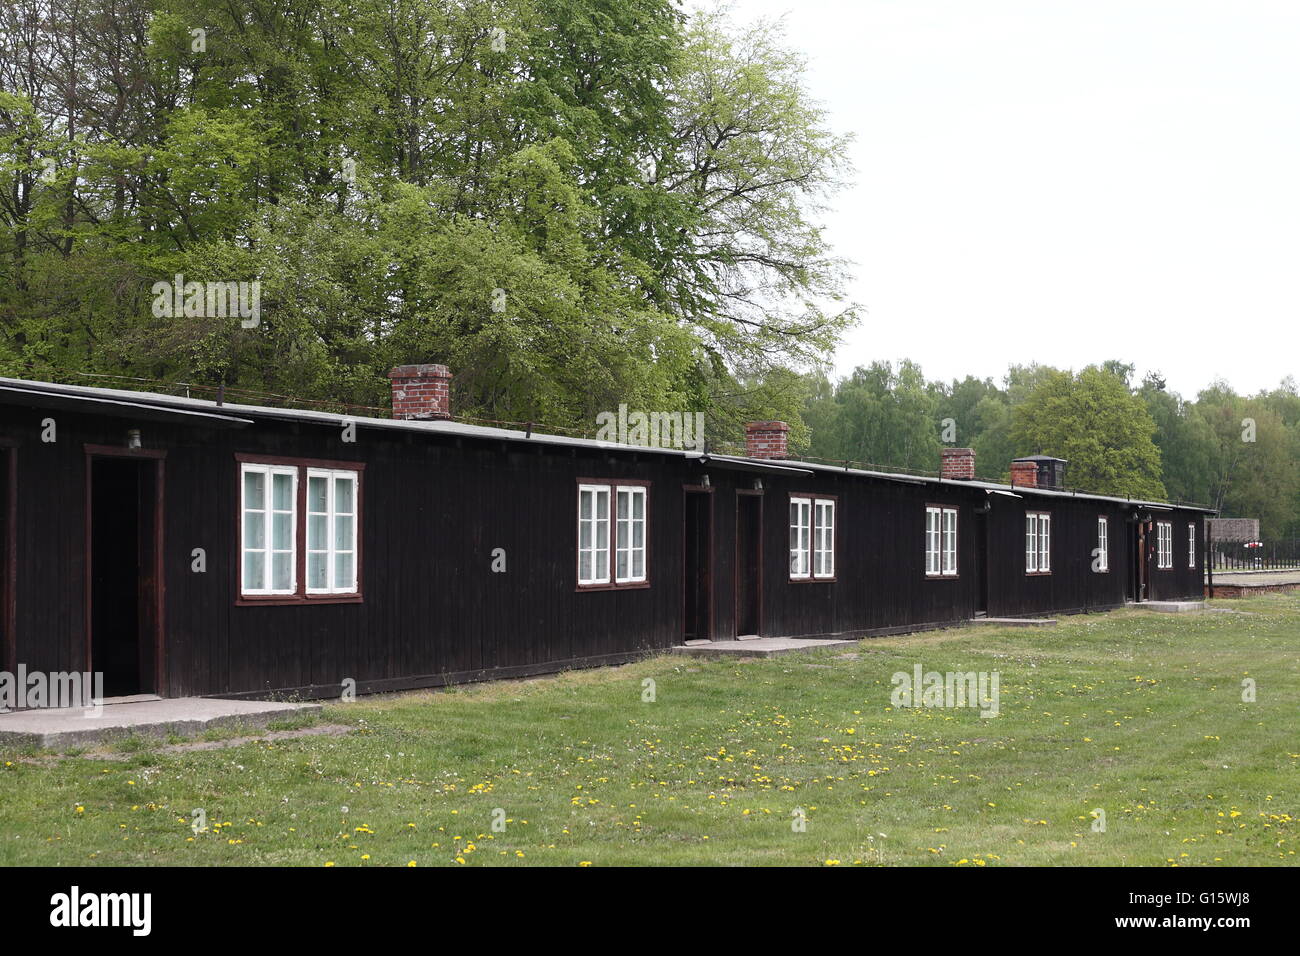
[0,377,1217,514]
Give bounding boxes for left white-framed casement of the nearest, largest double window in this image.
[239,462,298,594]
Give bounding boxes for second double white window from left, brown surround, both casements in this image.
[577,481,649,588]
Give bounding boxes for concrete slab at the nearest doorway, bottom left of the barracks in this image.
[0,697,321,749]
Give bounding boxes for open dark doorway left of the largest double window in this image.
[86,449,163,697]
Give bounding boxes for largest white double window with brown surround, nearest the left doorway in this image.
[239,457,363,601]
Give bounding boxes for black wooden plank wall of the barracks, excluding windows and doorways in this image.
[0,406,1200,696]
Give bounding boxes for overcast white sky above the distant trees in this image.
[732,0,1300,397]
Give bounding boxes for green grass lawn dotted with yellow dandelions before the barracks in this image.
[0,596,1300,866]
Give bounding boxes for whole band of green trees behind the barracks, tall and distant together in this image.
[0,0,1300,535]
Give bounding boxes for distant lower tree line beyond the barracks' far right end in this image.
[801,360,1300,538]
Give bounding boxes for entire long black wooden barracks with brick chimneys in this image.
[0,365,1206,696]
